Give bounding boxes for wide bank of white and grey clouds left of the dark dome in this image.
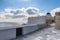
[0,7,46,23]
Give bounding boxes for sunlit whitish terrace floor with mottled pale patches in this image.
[14,23,60,40]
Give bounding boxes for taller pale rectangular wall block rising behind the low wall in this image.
[28,16,46,24]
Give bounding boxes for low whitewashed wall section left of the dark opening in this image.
[0,29,16,40]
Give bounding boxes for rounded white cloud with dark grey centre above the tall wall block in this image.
[25,7,39,17]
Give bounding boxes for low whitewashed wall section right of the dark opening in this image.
[22,24,47,35]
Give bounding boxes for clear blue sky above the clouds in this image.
[0,0,60,13]
